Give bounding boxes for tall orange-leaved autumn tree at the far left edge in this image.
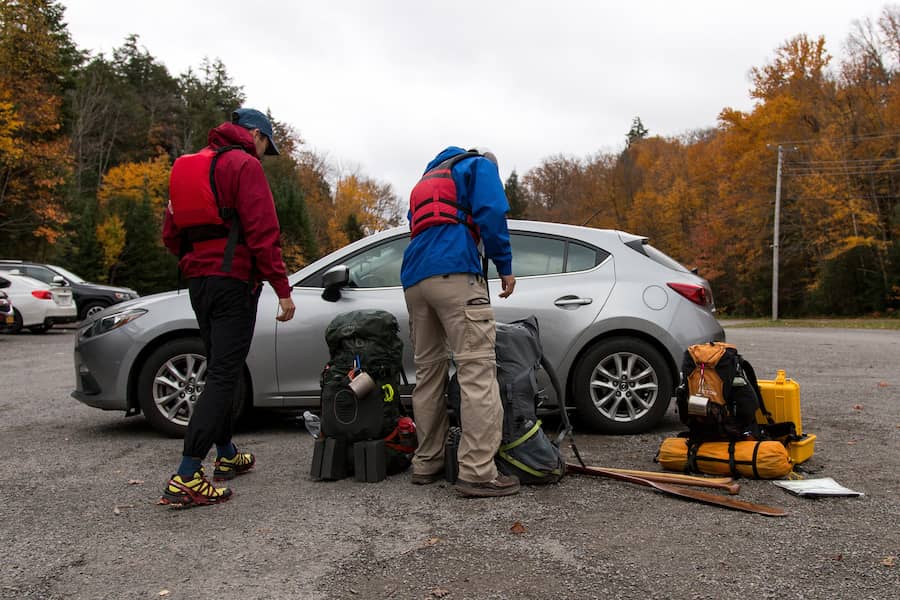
[0,0,79,256]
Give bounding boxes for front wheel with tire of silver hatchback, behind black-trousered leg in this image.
[138,337,248,438]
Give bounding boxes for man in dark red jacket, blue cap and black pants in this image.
[160,108,294,506]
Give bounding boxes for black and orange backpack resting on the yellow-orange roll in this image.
[675,342,795,442]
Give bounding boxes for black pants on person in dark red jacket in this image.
[184,277,260,459]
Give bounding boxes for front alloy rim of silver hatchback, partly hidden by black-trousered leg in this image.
[153,354,206,426]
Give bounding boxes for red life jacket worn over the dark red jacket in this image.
[168,146,242,273]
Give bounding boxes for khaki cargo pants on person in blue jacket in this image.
[405,273,503,482]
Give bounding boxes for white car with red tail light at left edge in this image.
[0,272,78,333]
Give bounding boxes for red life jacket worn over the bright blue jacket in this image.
[409,152,481,244]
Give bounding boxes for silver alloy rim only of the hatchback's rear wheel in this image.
[590,352,659,423]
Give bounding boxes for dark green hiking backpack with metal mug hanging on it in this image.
[320,310,403,443]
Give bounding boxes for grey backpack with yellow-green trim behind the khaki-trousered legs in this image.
[446,315,572,484]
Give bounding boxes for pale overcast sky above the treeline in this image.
[62,0,887,201]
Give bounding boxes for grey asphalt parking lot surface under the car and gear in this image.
[0,328,900,600]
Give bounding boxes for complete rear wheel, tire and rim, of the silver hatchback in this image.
[572,337,674,434]
